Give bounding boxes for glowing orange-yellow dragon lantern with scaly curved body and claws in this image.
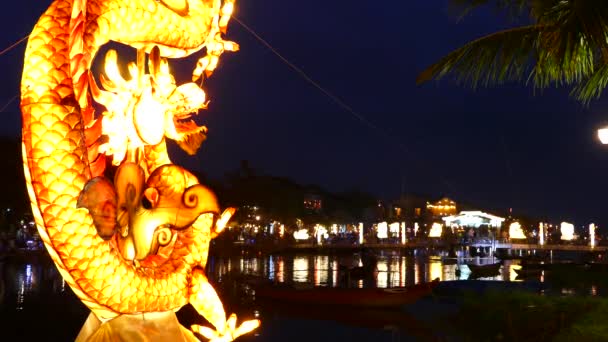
[21,0,259,341]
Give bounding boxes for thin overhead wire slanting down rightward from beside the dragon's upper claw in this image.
[231,15,456,193]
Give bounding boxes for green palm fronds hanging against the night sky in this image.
[416,0,608,103]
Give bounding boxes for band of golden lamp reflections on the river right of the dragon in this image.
[208,252,521,288]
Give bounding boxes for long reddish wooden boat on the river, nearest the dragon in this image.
[255,279,439,308]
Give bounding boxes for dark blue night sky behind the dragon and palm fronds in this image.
[0,0,608,224]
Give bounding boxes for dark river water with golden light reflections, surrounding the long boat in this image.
[0,251,602,341]
